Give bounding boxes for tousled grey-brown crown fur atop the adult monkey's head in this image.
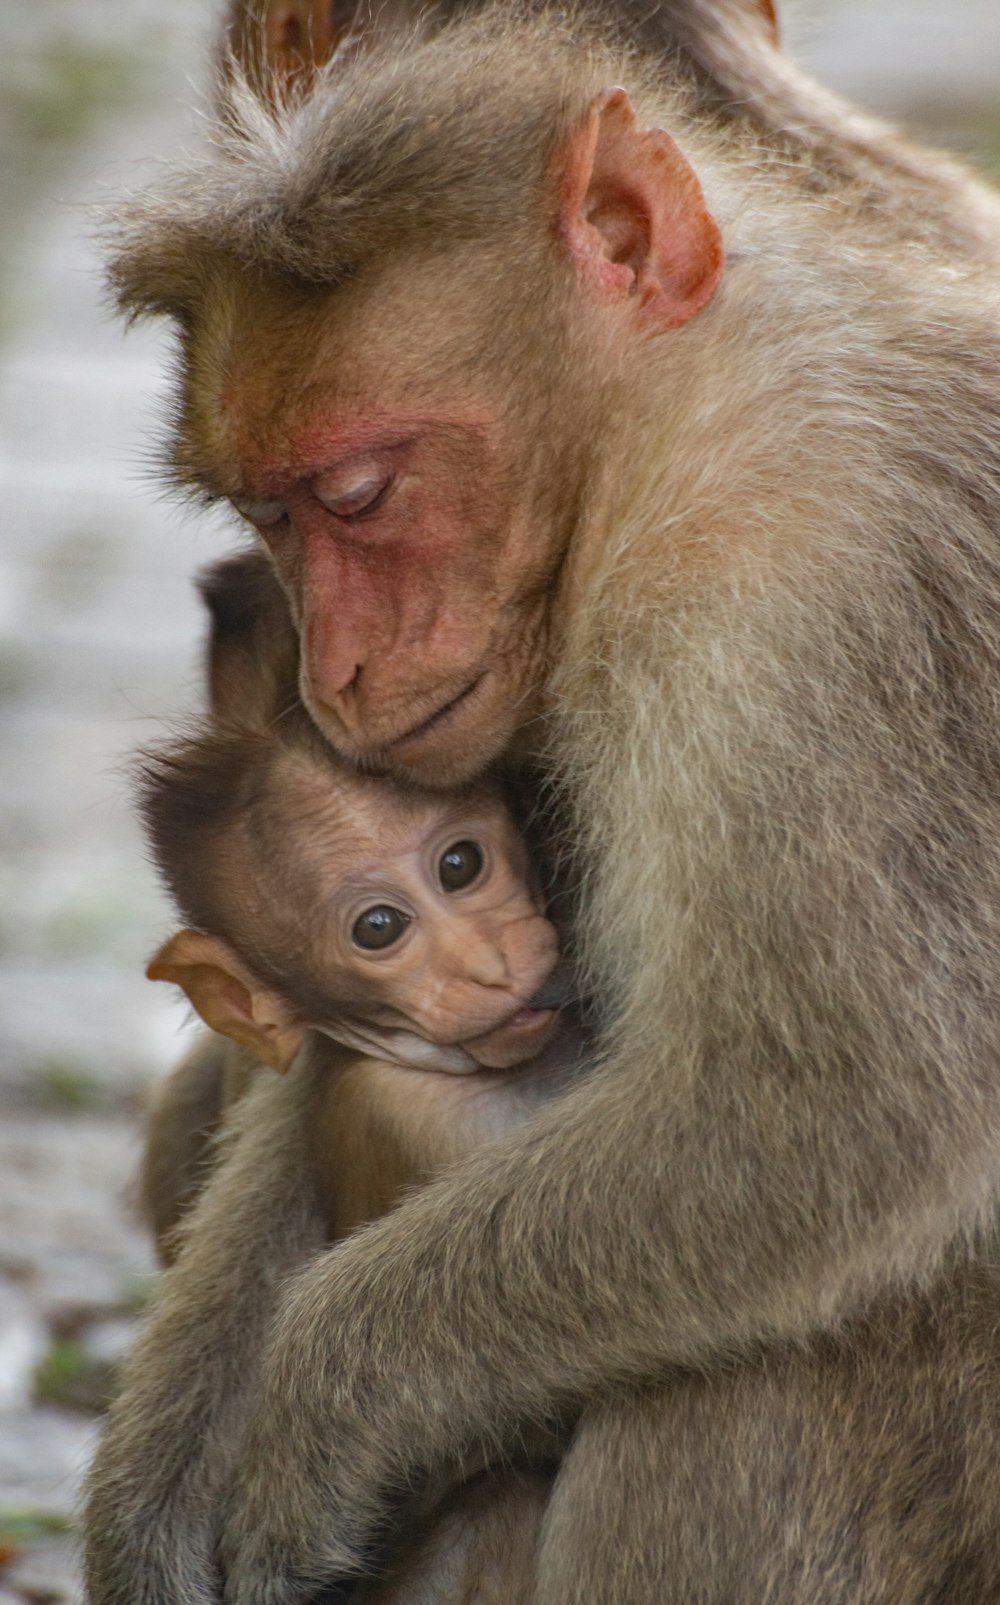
[108,10,648,321]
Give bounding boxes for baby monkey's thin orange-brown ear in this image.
[146,931,303,1071]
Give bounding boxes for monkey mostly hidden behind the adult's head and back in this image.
[226,0,1000,262]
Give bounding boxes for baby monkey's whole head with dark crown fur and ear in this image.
[140,708,557,1071]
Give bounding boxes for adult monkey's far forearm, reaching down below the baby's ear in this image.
[85,1066,326,1605]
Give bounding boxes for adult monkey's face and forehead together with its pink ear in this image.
[134,78,722,785]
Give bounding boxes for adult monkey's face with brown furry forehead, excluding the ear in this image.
[180,260,573,785]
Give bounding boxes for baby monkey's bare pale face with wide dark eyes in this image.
[310,793,559,1069]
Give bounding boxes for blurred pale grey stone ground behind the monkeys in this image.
[0,0,1000,1605]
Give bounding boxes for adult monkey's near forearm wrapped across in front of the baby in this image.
[226,956,1000,1605]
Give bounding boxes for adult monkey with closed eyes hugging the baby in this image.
[91,3,1000,1605]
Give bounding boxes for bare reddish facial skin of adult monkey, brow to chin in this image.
[218,394,549,785]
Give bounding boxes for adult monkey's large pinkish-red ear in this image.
[555,90,726,334]
